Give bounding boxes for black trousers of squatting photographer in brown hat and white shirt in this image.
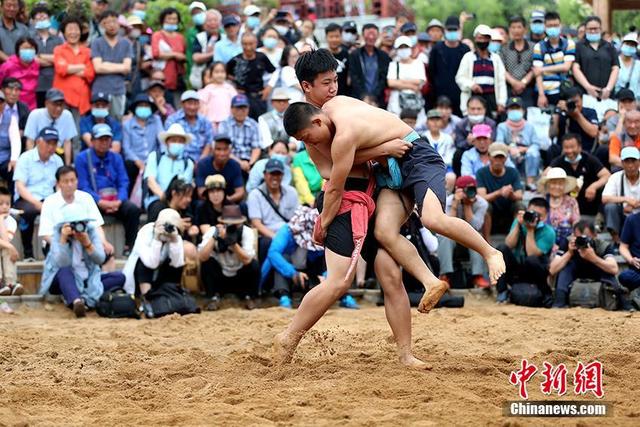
[201,258,260,298]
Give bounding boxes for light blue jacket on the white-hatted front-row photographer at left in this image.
[38,223,105,307]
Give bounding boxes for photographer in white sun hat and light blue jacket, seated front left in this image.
[38,203,125,317]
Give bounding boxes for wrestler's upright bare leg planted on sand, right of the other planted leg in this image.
[374,249,431,369]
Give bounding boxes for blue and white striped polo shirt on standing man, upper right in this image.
[533,37,576,95]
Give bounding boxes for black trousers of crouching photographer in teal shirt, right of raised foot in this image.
[496,244,551,295]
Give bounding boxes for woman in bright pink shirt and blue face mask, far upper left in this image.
[0,37,40,110]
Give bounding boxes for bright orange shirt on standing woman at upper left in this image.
[53,43,96,114]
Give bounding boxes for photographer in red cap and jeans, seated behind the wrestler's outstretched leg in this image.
[438,176,490,288]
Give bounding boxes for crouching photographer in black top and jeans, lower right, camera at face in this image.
[549,221,625,308]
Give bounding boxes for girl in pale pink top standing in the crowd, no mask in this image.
[198,62,238,131]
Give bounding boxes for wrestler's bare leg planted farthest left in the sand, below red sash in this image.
[273,248,354,363]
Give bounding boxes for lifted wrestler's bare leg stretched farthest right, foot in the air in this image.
[421,188,506,292]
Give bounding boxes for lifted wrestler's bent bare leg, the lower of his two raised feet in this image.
[375,189,448,311]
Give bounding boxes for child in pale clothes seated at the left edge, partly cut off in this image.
[0,187,24,295]
